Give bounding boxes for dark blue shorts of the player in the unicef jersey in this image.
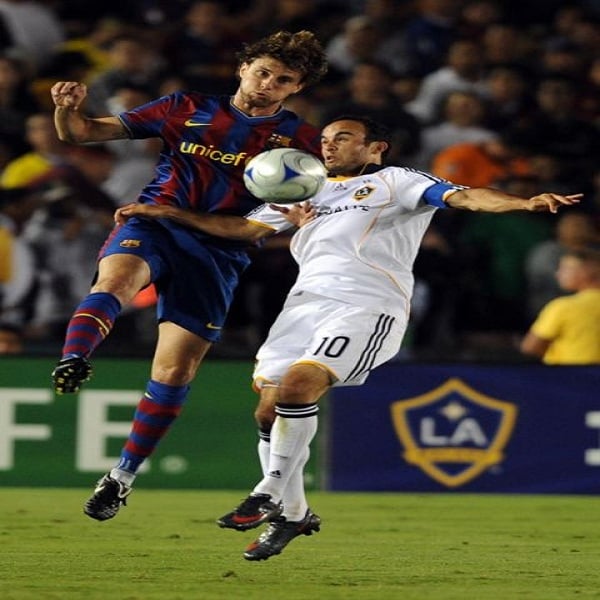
[99,218,250,342]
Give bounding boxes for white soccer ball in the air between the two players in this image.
[244,148,327,204]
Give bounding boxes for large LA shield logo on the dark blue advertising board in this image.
[391,378,518,487]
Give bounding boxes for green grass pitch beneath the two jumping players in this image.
[0,487,600,600]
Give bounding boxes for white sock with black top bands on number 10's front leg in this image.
[253,403,318,502]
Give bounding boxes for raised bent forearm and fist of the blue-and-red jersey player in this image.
[50,81,128,144]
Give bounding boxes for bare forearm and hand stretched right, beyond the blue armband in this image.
[446,188,583,213]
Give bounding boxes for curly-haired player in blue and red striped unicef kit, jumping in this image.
[51,31,327,521]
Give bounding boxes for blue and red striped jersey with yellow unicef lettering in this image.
[119,92,321,215]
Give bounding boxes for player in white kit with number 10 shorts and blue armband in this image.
[116,116,581,560]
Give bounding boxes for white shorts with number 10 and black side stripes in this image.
[253,292,407,389]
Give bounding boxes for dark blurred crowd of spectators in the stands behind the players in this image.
[0,0,600,360]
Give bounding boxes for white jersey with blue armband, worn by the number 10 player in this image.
[247,166,463,314]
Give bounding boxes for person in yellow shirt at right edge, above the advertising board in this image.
[521,243,600,365]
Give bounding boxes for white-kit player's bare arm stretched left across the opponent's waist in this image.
[114,202,273,242]
